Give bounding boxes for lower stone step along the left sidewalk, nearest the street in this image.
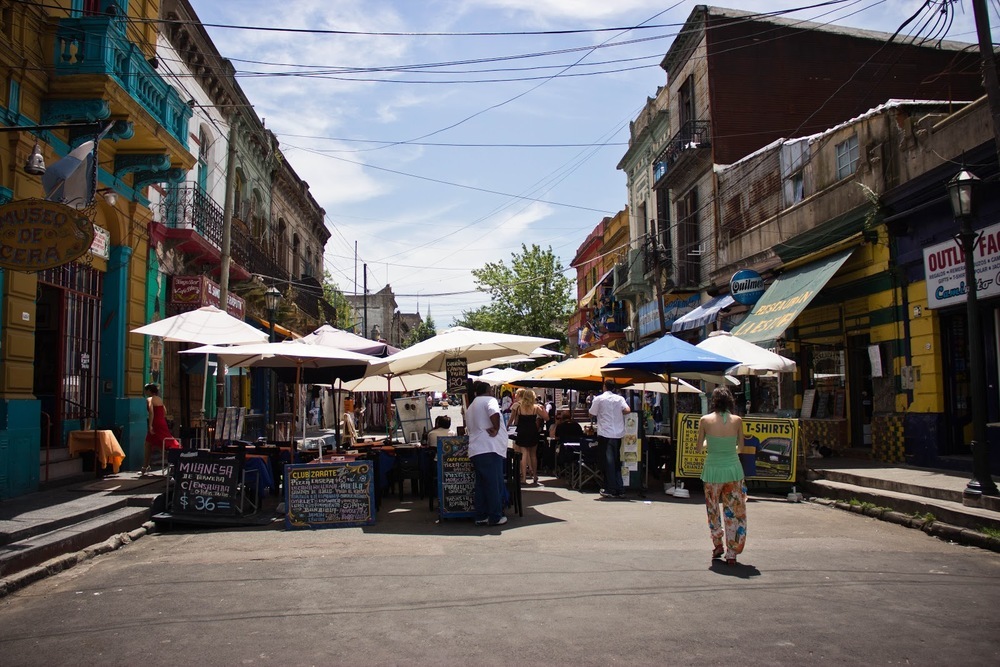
[0,505,151,577]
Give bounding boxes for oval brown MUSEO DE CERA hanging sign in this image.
[0,199,94,271]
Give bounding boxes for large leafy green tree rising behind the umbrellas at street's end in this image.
[457,243,575,344]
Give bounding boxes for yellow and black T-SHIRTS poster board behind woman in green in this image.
[675,414,799,482]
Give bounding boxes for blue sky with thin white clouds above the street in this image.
[192,0,997,329]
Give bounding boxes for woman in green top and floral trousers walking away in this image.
[698,387,747,565]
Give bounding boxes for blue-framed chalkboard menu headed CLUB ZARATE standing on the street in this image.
[285,461,375,529]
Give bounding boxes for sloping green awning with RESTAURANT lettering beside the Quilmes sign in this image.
[732,248,854,343]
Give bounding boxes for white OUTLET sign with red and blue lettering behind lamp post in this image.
[924,224,1000,308]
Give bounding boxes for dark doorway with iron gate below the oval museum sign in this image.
[33,264,103,447]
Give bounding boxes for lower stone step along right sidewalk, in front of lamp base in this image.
[806,479,1000,530]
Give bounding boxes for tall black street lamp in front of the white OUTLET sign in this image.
[948,169,1000,498]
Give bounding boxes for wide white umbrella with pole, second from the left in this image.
[184,341,377,461]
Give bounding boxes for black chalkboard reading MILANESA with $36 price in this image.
[171,450,243,516]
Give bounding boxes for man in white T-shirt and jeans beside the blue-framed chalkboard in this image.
[465,381,508,526]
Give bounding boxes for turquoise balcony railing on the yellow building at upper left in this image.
[54,16,192,149]
